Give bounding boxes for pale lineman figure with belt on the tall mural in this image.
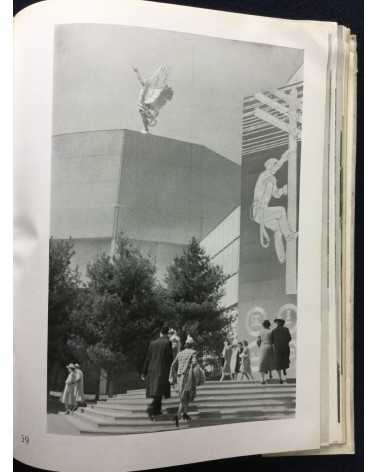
[250,151,297,264]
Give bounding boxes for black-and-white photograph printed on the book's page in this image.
[47,24,305,435]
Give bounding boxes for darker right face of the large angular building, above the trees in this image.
[118,130,240,245]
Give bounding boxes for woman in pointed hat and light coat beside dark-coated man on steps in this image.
[169,335,205,426]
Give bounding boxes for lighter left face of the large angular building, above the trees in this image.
[50,130,123,239]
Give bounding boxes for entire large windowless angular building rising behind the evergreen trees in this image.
[51,130,240,280]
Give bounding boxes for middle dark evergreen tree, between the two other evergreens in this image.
[70,235,175,376]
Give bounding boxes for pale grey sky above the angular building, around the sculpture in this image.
[53,24,303,163]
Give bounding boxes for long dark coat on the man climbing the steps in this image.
[143,336,173,398]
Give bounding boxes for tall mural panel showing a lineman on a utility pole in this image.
[238,82,303,377]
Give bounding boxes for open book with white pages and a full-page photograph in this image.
[14,0,356,472]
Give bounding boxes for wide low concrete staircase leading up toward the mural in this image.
[66,381,295,435]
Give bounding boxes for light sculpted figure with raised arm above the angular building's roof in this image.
[133,66,173,133]
